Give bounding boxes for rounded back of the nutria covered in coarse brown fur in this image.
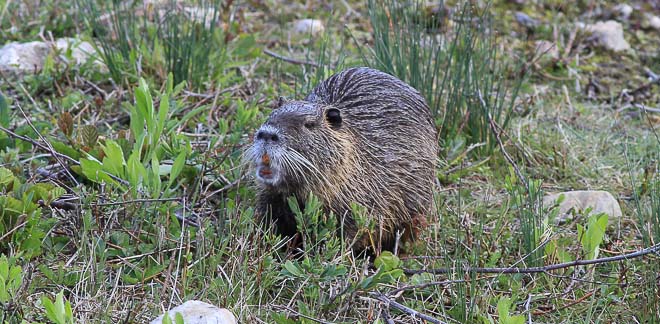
[306,68,438,249]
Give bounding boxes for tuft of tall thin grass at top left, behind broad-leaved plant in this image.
[77,0,237,89]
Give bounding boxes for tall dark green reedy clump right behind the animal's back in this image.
[361,0,524,156]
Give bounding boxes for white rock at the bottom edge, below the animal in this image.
[151,300,238,324]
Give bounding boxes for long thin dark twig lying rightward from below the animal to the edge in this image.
[403,243,660,275]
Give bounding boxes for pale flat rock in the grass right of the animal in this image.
[543,190,623,218]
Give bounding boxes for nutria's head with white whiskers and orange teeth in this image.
[247,101,346,191]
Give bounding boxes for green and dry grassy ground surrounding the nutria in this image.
[0,0,660,323]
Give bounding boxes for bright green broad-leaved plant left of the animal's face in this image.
[80,75,190,198]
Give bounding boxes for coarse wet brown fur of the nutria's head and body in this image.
[246,68,438,254]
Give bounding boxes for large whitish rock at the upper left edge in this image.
[0,38,96,74]
